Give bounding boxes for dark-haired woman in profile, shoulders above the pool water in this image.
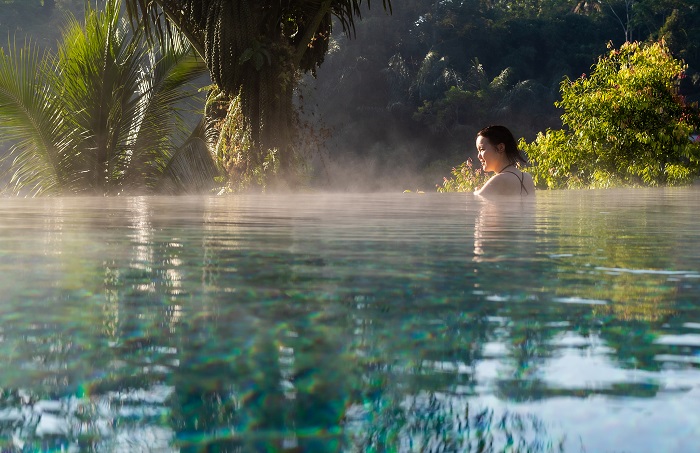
[474,126,535,197]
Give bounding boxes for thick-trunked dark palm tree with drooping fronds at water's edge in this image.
[125,0,391,189]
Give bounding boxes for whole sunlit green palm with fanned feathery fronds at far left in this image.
[0,0,211,194]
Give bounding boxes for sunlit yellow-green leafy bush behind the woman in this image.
[521,38,700,188]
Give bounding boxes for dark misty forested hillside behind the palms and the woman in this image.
[0,0,700,191]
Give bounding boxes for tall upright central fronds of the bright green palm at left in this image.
[59,0,157,193]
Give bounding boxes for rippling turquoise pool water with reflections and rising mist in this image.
[0,188,700,452]
